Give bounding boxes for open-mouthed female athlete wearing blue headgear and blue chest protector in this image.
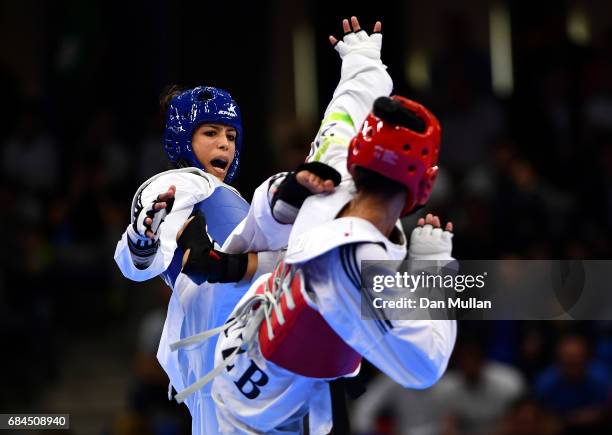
[115,86,333,434]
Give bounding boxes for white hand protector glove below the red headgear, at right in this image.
[408,224,454,261]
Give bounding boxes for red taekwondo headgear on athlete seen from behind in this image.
[347,95,441,216]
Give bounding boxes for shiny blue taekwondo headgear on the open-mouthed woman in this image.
[164,86,242,183]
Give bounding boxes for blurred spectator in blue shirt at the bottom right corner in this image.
[534,335,611,434]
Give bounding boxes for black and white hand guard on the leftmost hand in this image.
[127,190,174,269]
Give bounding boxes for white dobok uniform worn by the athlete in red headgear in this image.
[203,33,456,434]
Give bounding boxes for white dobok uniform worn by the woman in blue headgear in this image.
[115,168,276,435]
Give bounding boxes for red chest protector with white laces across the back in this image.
[256,262,361,378]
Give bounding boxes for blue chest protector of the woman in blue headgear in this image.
[163,183,249,287]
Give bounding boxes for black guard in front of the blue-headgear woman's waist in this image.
[177,212,248,285]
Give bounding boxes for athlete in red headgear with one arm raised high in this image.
[175,18,456,434]
